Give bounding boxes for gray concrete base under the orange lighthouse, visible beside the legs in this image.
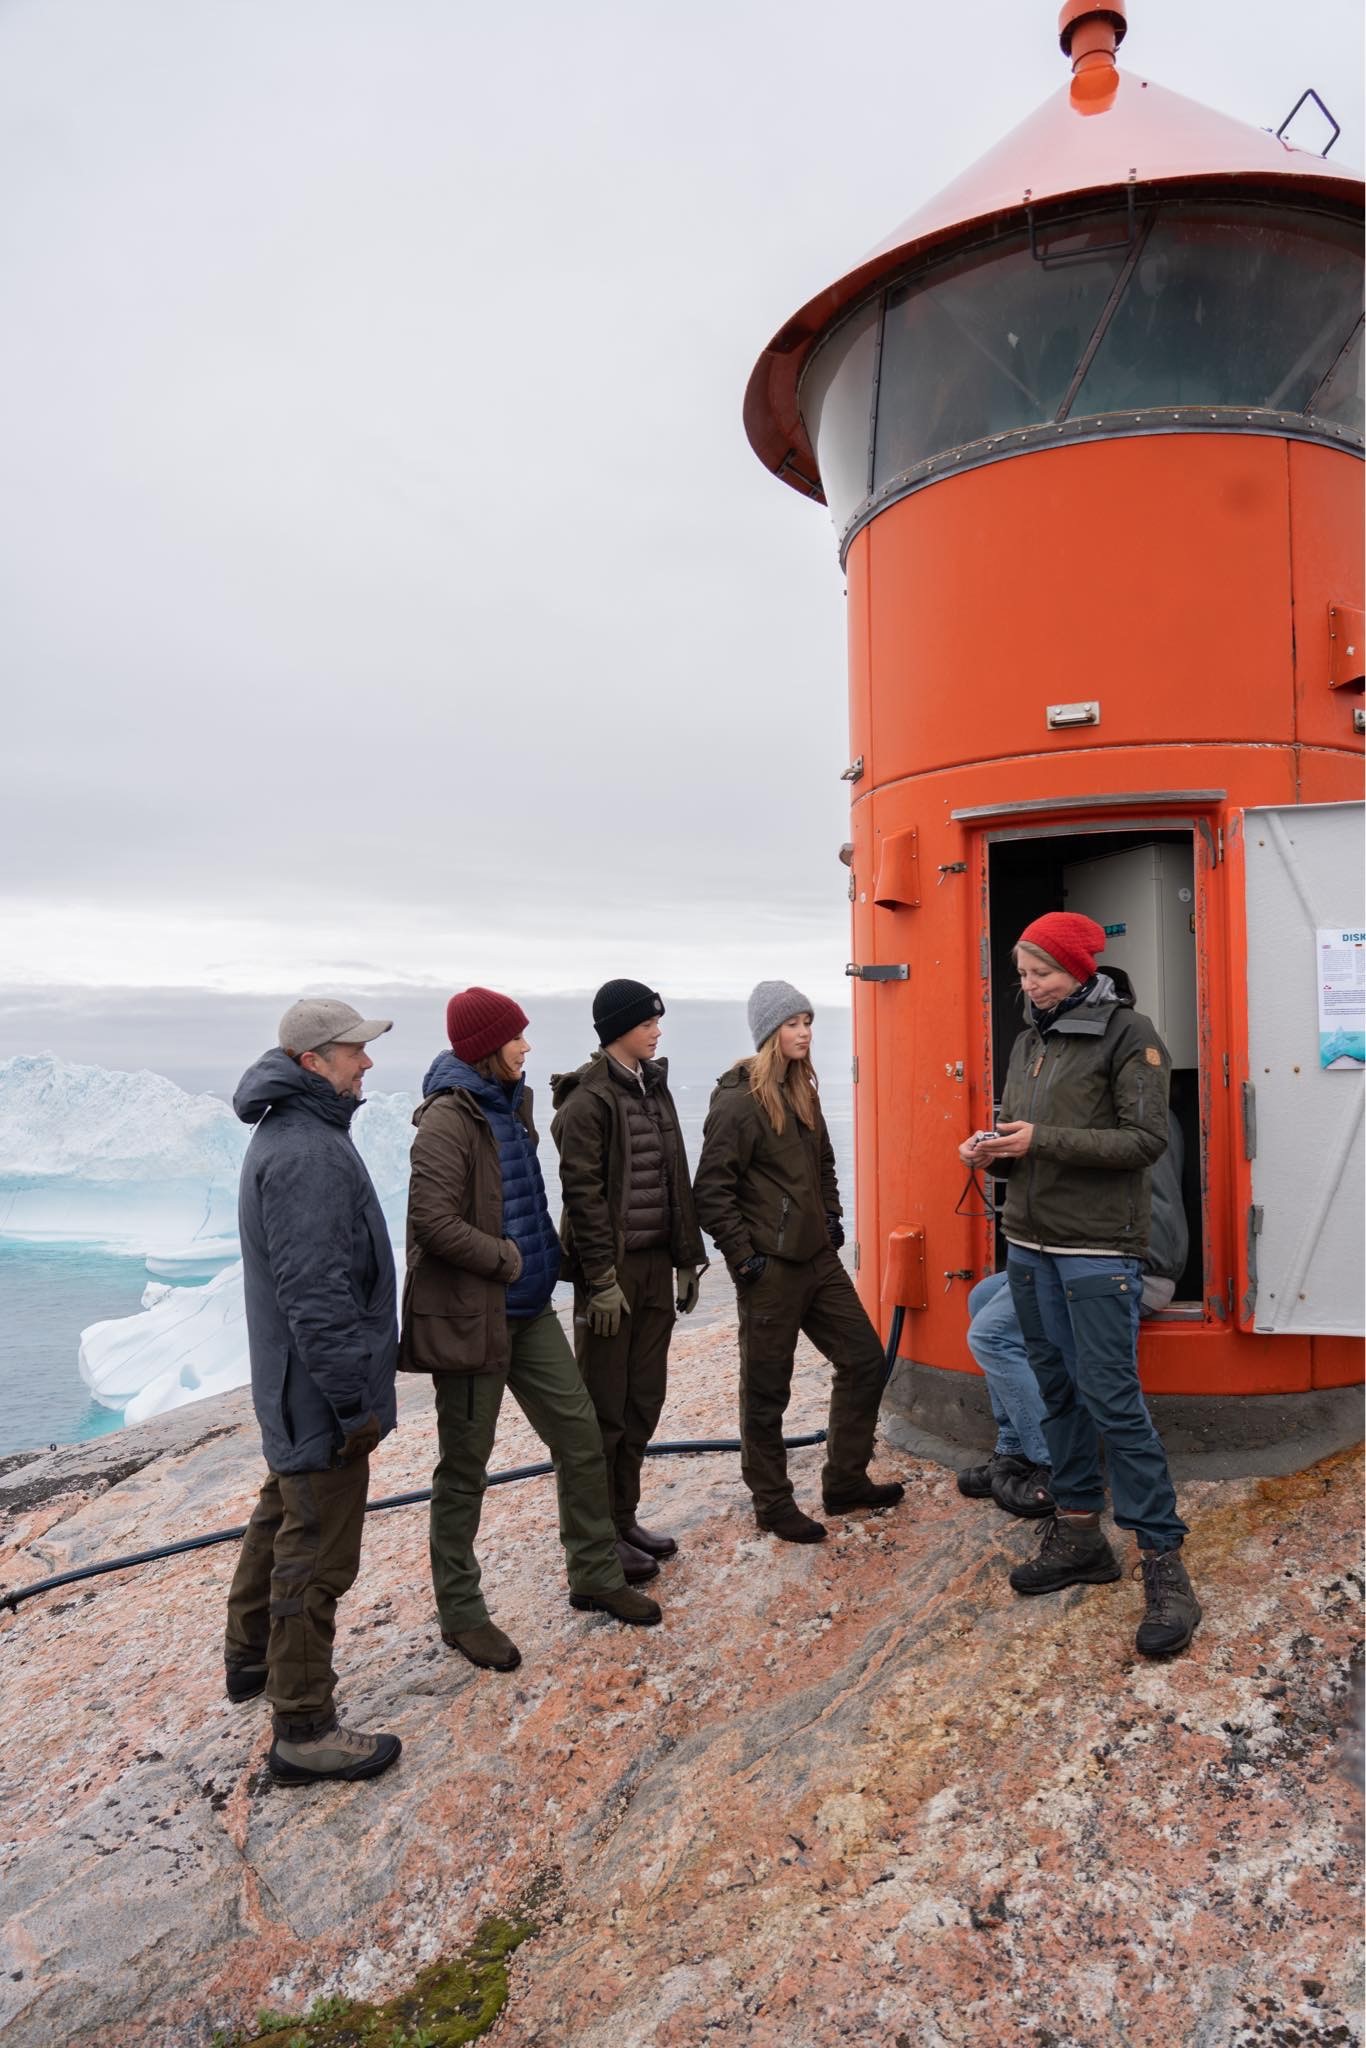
[881,1358,1364,1479]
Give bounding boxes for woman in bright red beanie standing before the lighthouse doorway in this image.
[958,911,1200,1657]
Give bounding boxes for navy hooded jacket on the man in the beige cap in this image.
[233,1051,397,1473]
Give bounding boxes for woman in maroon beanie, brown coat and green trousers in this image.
[399,987,659,1671]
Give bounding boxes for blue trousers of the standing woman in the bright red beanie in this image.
[1006,1245,1186,1550]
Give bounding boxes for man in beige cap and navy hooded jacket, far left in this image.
[223,997,401,1786]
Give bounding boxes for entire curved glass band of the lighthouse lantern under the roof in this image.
[801,199,1362,532]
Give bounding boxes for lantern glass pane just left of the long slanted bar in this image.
[874,213,1128,483]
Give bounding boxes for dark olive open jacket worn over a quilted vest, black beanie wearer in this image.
[551,1053,707,1282]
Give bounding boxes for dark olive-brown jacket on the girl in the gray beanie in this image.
[692,1061,840,1268]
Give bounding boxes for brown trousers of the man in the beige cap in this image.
[223,1456,371,1741]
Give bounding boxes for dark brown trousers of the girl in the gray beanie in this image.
[735,1251,883,1518]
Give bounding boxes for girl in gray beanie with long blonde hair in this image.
[692,981,905,1542]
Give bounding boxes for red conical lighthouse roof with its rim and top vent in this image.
[745,0,1362,496]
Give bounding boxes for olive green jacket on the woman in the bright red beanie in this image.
[989,975,1171,1260]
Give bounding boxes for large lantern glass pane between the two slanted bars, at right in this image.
[1071,205,1360,418]
